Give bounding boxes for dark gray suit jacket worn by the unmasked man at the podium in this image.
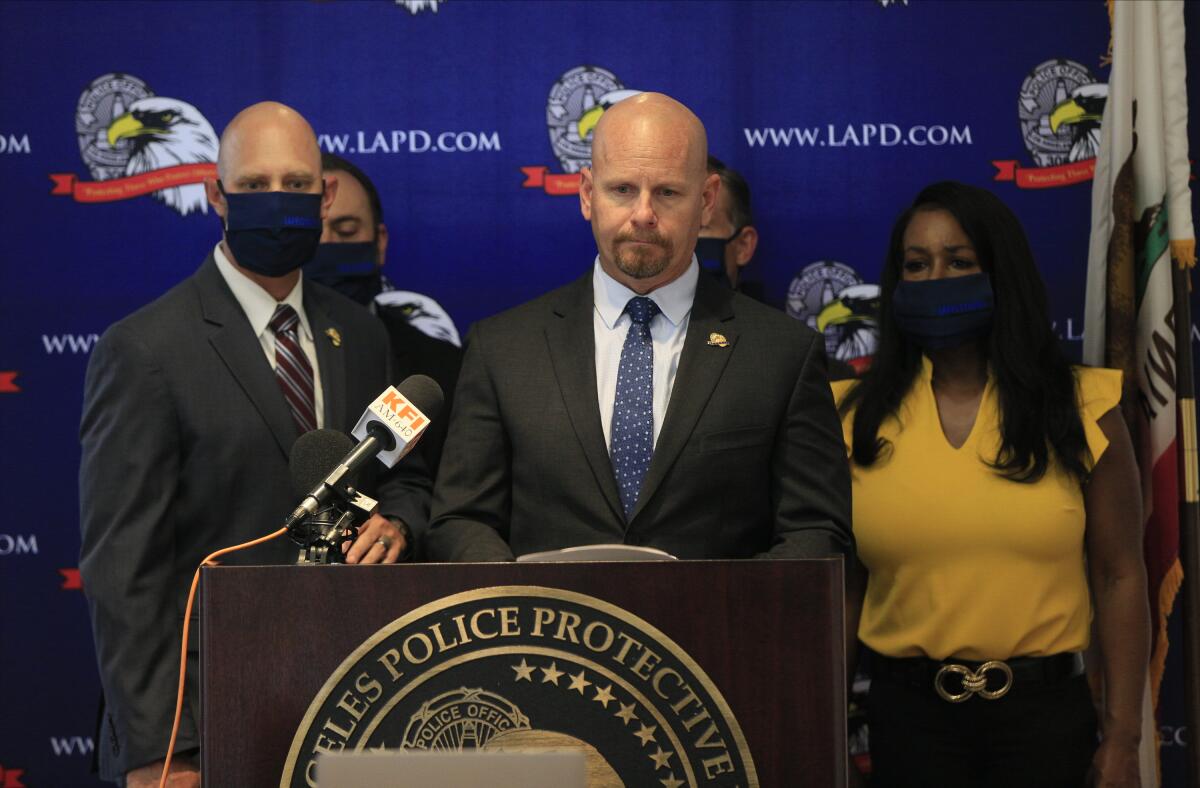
[427,271,852,561]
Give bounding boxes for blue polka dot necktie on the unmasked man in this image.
[608,295,659,519]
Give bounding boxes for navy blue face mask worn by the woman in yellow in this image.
[892,273,995,350]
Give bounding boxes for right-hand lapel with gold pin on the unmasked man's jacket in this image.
[630,275,737,523]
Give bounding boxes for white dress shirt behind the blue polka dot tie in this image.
[592,254,700,446]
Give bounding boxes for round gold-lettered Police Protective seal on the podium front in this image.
[280,585,758,788]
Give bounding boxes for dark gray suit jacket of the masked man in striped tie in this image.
[79,255,430,780]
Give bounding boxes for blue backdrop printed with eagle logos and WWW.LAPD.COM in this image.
[0,0,1200,787]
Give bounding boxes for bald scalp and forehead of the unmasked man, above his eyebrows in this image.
[592,94,708,180]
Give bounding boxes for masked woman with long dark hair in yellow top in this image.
[834,182,1150,788]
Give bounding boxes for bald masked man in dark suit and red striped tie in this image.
[79,102,430,786]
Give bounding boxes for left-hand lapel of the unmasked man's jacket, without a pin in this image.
[546,269,625,523]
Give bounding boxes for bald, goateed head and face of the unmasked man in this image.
[580,94,720,294]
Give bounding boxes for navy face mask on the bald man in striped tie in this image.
[217,181,322,277]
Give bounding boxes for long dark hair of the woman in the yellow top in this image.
[841,181,1092,483]
